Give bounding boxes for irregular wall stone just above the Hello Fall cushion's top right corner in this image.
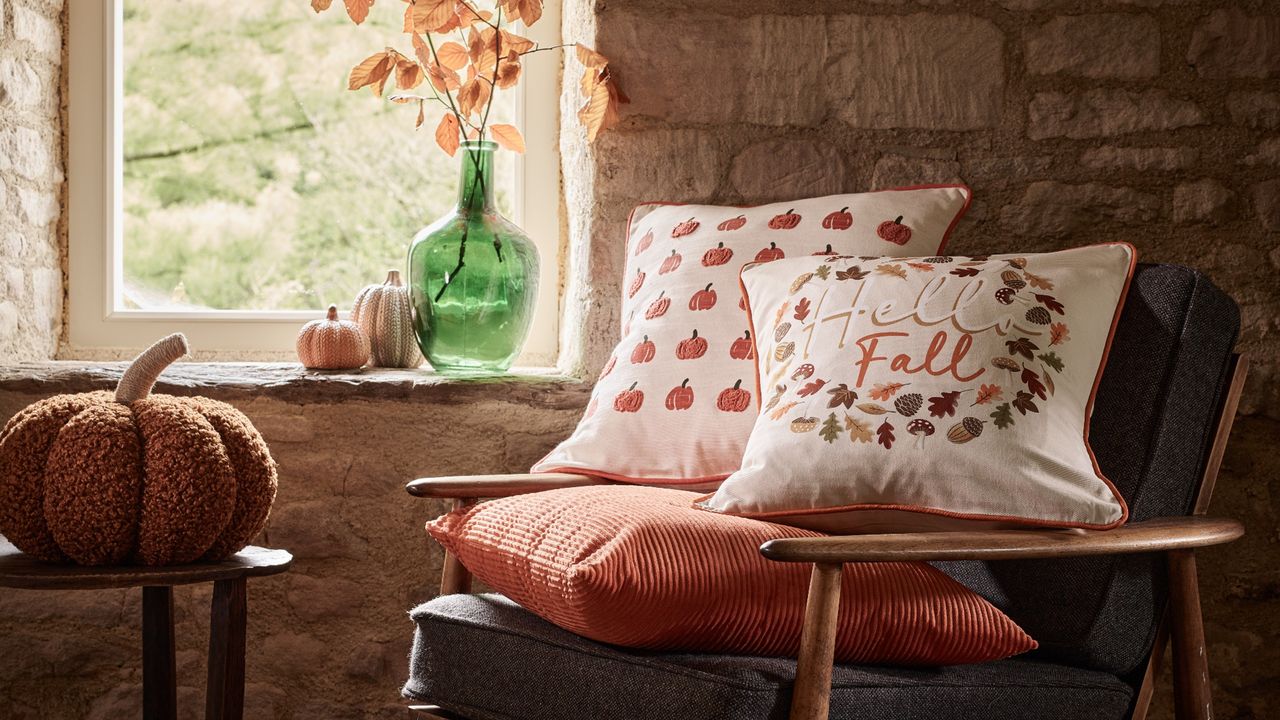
[1000,181,1161,240]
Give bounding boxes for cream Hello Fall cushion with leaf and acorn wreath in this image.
[701,243,1135,532]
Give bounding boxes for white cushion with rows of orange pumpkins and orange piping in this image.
[534,186,969,486]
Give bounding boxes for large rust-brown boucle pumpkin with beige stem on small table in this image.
[0,334,276,565]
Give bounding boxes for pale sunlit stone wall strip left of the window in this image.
[0,0,63,363]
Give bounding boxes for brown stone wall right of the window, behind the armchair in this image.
[562,0,1280,719]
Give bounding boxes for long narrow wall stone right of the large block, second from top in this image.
[1027,90,1207,140]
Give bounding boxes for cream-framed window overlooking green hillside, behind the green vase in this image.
[68,0,559,365]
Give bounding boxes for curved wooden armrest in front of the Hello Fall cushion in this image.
[760,515,1244,562]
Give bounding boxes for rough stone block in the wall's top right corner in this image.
[1187,5,1280,78]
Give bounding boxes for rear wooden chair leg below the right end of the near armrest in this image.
[1169,550,1213,720]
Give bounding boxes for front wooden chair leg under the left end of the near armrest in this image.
[791,562,844,720]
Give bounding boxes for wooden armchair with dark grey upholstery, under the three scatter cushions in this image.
[404,266,1248,720]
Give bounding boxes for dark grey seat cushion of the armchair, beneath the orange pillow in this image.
[403,594,1133,720]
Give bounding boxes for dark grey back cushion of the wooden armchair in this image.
[938,260,1240,678]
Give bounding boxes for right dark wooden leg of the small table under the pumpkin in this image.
[205,578,247,720]
